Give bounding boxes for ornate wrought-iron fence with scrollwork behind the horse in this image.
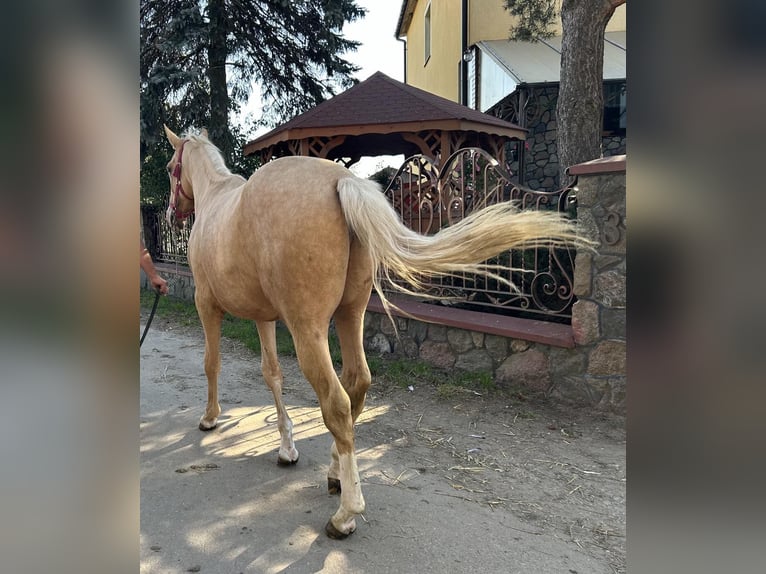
[144,148,576,322]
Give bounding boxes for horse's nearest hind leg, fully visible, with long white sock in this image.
[293,326,364,538]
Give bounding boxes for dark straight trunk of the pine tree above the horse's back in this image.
[207,0,234,166]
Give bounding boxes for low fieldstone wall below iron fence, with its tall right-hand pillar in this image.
[364,156,626,412]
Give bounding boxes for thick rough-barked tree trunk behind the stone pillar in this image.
[556,0,622,187]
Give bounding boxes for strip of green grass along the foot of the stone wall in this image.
[141,290,495,399]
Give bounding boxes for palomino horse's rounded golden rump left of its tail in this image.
[229,157,358,320]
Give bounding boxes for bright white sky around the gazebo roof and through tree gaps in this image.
[246,0,404,177]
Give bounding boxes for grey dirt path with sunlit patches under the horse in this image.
[140,319,626,574]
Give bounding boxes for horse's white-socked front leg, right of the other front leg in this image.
[255,321,298,465]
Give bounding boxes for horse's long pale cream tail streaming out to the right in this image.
[338,177,592,318]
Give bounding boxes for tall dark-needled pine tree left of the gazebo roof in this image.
[140,0,365,171]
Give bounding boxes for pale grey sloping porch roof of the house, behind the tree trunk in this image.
[484,31,627,84]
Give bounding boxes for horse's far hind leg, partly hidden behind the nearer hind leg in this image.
[327,302,371,494]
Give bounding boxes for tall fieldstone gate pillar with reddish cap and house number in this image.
[568,155,627,411]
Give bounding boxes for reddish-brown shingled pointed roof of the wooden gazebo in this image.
[244,72,526,155]
